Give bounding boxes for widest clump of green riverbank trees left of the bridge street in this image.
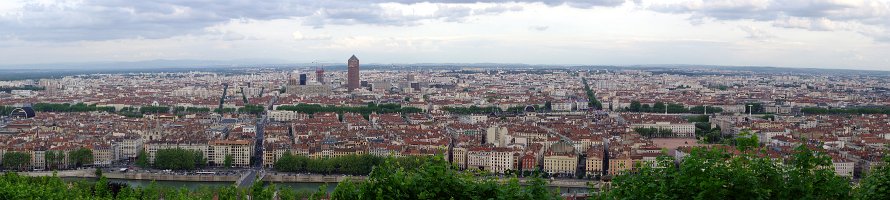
[147,148,207,170]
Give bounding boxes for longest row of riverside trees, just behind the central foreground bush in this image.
[273,153,425,175]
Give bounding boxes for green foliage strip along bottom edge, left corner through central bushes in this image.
[0,157,558,200]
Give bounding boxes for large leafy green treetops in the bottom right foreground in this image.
[598,142,872,199]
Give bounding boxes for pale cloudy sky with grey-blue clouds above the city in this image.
[0,0,890,70]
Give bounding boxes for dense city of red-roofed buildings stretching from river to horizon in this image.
[0,56,890,198]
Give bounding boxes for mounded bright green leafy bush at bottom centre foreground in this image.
[331,156,559,200]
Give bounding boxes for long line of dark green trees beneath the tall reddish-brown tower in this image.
[276,103,423,116]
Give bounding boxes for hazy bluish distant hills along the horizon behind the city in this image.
[0,59,890,80]
